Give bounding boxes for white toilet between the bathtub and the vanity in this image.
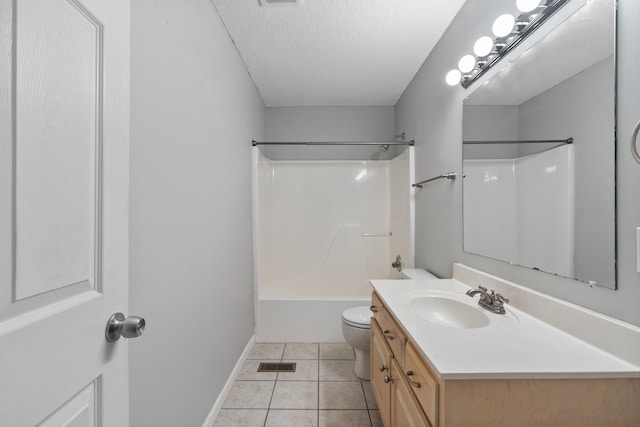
[342,268,437,380]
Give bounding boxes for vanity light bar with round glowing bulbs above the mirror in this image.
[445,0,569,89]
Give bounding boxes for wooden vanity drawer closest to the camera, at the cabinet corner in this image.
[403,342,438,426]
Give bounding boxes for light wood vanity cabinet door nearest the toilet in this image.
[371,319,392,427]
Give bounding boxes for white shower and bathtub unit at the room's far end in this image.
[253,147,414,342]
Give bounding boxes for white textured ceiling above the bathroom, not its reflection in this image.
[212,0,465,107]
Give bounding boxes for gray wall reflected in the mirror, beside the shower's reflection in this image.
[518,57,615,287]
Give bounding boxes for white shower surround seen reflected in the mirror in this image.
[464,145,575,277]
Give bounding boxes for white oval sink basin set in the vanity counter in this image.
[409,293,489,328]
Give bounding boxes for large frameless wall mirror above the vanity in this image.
[463,0,616,289]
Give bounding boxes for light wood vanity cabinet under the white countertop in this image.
[371,292,640,427]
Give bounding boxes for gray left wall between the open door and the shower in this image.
[129,0,265,427]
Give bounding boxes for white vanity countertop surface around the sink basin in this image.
[371,279,640,379]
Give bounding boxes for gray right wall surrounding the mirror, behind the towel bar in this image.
[396,0,640,325]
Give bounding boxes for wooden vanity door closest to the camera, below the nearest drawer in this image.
[391,360,431,427]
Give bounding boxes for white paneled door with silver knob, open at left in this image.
[0,0,129,427]
